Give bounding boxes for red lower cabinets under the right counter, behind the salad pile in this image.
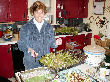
[50,33,92,52]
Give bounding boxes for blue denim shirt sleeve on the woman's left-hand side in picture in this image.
[17,26,28,52]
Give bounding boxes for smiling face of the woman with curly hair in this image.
[33,9,45,23]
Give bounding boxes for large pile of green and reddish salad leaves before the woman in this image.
[39,50,82,70]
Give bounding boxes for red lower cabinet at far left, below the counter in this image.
[0,45,14,78]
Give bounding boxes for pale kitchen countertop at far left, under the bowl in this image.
[0,34,18,45]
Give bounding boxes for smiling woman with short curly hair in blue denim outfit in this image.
[18,1,59,70]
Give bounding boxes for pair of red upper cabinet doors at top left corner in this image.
[0,0,28,22]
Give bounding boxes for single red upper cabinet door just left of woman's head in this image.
[10,0,28,21]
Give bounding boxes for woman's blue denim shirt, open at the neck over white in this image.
[18,19,57,60]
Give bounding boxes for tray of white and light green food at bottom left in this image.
[20,67,55,82]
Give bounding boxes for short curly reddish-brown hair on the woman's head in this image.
[30,1,47,15]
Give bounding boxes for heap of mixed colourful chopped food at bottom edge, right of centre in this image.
[58,67,96,82]
